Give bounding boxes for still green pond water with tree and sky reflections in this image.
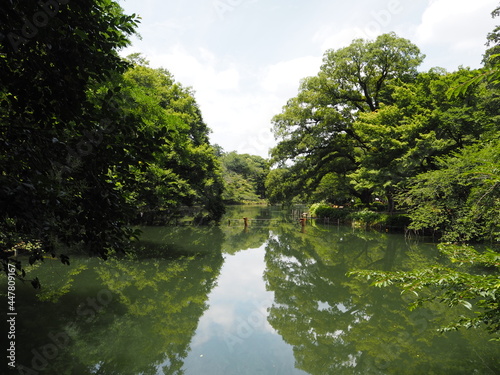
[0,207,500,375]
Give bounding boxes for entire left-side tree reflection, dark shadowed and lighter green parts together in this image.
[1,228,223,375]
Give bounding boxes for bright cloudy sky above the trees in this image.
[119,0,500,158]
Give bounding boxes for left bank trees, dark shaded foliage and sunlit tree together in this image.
[0,0,224,280]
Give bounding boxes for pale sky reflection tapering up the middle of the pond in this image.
[180,245,305,375]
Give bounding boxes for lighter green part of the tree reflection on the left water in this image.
[70,252,222,374]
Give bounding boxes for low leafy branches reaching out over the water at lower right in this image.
[352,245,500,340]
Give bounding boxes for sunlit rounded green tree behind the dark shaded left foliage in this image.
[117,55,224,220]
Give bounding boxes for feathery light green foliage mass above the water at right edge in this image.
[401,140,500,242]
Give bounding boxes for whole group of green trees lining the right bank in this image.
[266,30,500,241]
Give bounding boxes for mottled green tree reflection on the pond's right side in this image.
[265,226,498,374]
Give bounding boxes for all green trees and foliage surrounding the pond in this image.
[0,0,500,340]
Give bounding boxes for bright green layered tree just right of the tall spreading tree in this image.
[349,69,498,210]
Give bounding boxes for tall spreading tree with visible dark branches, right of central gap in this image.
[272,33,424,206]
